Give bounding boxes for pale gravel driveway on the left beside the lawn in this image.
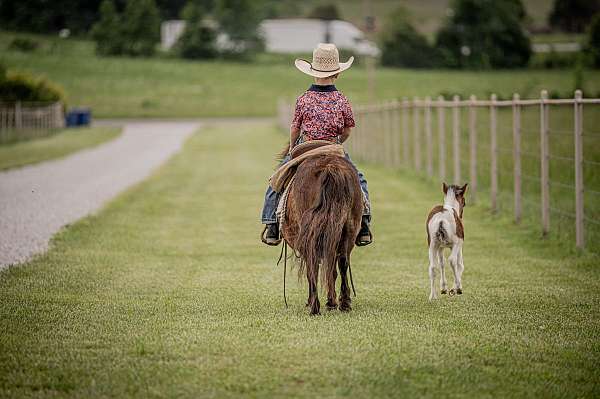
[0,122,199,270]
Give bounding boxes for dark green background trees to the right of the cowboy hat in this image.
[381,0,600,69]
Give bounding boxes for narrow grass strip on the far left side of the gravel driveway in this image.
[0,127,120,170]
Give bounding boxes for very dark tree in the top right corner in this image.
[548,0,600,33]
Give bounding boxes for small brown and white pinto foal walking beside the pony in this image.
[426,183,467,300]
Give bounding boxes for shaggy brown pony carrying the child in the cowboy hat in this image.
[282,155,363,315]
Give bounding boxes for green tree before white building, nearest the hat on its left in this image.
[216,0,263,58]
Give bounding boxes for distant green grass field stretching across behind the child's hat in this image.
[0,32,600,118]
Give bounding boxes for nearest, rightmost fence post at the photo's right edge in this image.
[574,90,585,248]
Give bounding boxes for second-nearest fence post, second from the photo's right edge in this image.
[540,90,550,236]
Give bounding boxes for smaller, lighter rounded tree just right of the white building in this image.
[381,8,440,68]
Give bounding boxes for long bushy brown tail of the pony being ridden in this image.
[297,160,357,296]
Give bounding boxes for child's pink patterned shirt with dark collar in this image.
[292,85,355,141]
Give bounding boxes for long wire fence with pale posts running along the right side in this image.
[278,91,600,252]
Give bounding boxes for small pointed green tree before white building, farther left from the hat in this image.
[176,0,217,59]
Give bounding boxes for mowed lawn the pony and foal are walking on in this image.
[0,123,600,398]
